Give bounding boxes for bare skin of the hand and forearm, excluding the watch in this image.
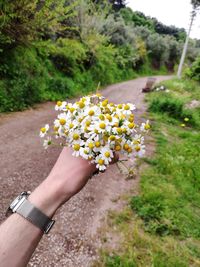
[0,148,117,267]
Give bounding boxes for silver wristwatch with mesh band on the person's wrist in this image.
[6,191,55,234]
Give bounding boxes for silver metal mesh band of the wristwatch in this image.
[16,199,55,234]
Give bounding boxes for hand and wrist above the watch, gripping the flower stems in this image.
[29,147,118,217]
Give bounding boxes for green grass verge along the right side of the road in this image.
[95,80,200,267]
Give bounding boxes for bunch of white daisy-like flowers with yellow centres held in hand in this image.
[40,94,150,171]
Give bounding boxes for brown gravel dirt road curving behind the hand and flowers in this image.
[0,76,172,267]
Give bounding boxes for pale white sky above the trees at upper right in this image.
[127,0,200,39]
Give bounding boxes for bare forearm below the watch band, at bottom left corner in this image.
[0,214,42,267]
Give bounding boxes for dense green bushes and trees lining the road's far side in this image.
[0,0,200,112]
